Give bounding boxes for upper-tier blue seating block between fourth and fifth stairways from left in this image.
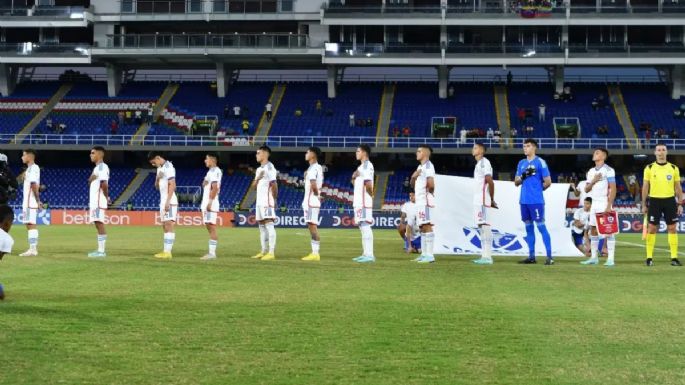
[390,83,497,137]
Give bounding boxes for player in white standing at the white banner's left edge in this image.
[411,144,435,263]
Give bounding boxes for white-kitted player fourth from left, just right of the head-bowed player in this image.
[200,152,223,261]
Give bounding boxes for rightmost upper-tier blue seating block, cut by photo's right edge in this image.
[621,84,685,138]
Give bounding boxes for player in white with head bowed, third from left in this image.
[147,151,178,259]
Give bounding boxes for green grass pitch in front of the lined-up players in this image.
[0,226,685,385]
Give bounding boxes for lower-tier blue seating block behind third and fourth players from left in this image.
[125,168,252,211]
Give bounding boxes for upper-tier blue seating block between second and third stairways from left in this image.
[167,82,273,134]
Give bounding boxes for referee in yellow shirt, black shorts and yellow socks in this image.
[642,144,683,266]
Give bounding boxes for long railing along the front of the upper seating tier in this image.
[0,134,685,150]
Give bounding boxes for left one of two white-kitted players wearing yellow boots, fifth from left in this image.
[251,146,278,261]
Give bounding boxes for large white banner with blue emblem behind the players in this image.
[432,175,582,257]
